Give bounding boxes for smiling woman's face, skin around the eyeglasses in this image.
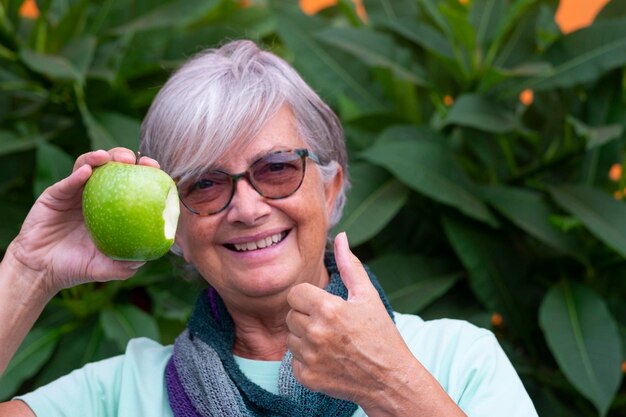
[176,107,342,310]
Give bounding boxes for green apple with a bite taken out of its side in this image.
[83,162,180,261]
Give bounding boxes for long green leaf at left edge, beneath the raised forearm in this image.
[0,327,60,401]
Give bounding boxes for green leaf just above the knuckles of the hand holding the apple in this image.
[33,140,74,196]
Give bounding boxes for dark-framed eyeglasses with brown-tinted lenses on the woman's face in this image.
[178,149,320,216]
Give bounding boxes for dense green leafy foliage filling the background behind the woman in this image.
[0,0,626,416]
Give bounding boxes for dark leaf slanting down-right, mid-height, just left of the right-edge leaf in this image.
[480,186,580,257]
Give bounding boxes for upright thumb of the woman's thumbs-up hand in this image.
[335,232,374,300]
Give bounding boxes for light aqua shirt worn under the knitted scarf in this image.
[17,313,537,417]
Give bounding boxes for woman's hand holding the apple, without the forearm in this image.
[7,148,159,295]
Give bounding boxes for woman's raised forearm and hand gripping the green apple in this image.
[0,148,158,376]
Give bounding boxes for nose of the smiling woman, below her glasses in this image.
[226,178,271,224]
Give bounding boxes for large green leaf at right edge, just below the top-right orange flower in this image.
[519,19,626,91]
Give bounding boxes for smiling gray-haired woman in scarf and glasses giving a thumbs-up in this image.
[0,41,536,417]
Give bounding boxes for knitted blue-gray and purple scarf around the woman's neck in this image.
[165,253,393,417]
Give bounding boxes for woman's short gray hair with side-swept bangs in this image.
[140,40,349,227]
